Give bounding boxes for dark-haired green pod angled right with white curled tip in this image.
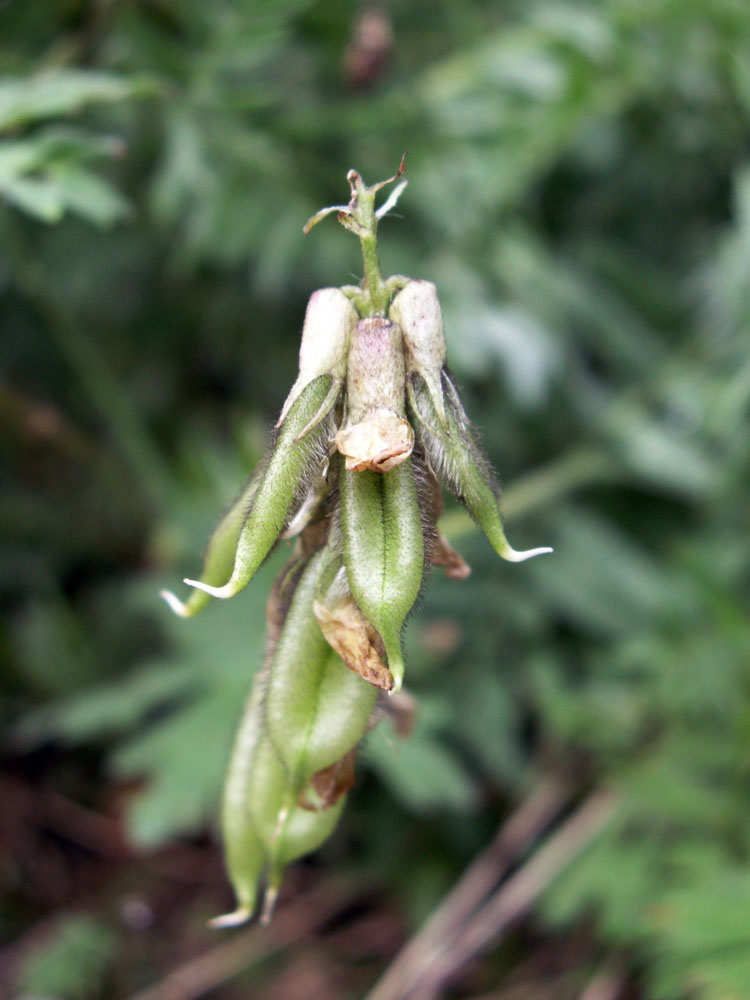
[413,371,552,562]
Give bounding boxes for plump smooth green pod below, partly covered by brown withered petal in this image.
[265,548,377,795]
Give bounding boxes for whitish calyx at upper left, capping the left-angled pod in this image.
[276,288,359,427]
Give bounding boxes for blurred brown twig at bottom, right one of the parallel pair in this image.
[412,790,615,1000]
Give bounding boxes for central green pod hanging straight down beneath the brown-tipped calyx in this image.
[340,459,424,693]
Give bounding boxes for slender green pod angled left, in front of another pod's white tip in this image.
[185,375,338,597]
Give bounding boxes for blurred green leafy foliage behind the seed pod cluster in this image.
[0,0,750,1000]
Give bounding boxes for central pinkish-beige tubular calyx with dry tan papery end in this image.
[336,316,414,472]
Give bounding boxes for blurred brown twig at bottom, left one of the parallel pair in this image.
[367,776,572,1000]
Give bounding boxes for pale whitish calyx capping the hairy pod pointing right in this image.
[388,279,445,424]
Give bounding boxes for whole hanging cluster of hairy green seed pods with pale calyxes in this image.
[163,164,550,926]
